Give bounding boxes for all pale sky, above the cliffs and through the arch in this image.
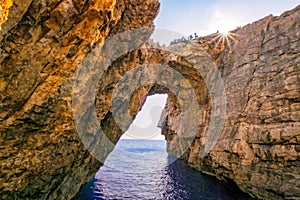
[122,0,300,139]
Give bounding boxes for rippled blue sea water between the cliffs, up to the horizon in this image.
[74,139,251,200]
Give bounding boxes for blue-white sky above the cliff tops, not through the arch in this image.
[153,0,300,44]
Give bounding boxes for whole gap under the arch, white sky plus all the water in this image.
[73,93,248,200]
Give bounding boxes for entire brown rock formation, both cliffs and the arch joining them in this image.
[0,0,300,199]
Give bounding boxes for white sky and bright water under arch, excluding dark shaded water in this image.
[74,94,175,199]
